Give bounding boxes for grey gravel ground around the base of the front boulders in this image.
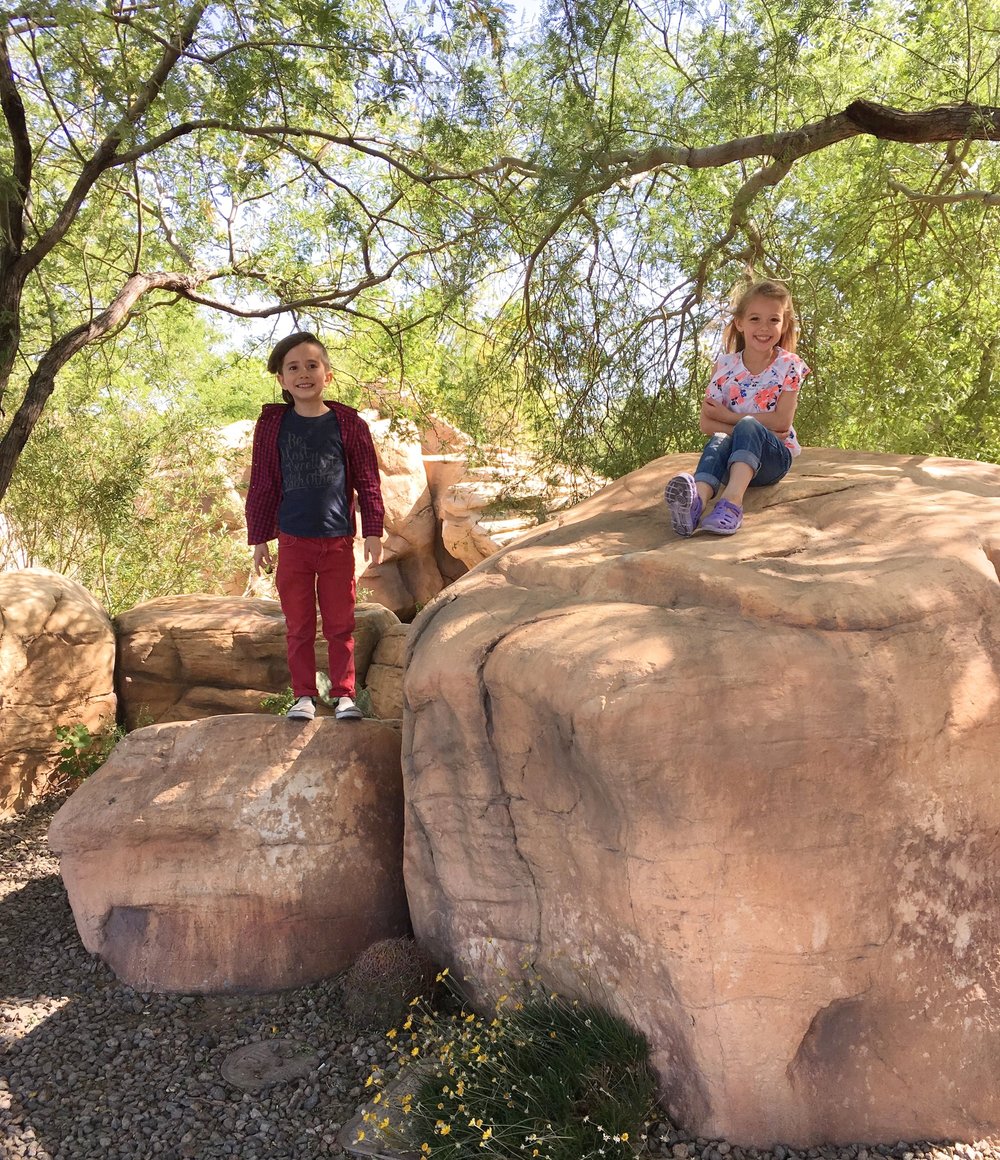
[0,798,1000,1160]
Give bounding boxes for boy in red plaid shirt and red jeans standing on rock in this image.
[246,331,385,720]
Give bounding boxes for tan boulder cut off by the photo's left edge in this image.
[0,568,116,817]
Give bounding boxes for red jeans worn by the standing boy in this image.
[275,531,354,701]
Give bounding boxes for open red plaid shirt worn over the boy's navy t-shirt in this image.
[246,399,385,544]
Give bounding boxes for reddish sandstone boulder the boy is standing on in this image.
[49,715,408,992]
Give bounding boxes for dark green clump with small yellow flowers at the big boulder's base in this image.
[358,972,655,1160]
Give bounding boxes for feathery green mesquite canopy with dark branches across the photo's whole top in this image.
[0,0,1000,496]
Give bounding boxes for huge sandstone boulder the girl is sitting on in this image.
[404,450,1000,1145]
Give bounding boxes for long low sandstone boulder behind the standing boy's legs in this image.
[115,596,399,728]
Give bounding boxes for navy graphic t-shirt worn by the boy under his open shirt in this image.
[277,407,354,536]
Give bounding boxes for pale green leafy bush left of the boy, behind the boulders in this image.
[5,312,247,616]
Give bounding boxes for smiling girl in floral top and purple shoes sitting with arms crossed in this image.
[664,282,809,536]
